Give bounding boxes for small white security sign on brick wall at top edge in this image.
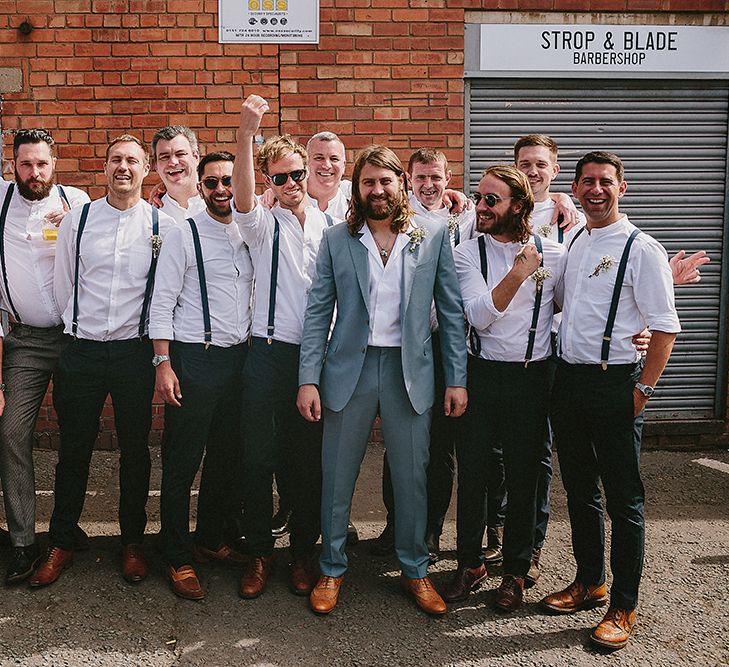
[218,0,319,44]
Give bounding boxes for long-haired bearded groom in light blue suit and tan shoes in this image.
[297,146,467,614]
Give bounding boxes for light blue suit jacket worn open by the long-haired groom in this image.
[299,218,466,414]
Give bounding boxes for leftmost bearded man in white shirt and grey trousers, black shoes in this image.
[0,130,89,584]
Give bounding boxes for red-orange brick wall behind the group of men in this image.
[0,0,729,446]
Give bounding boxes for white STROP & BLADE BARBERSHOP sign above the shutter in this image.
[480,24,729,72]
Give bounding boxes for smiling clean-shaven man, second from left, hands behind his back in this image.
[30,134,174,586]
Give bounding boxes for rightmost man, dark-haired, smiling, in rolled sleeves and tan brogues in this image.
[542,151,680,649]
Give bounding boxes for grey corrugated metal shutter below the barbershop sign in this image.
[466,79,729,419]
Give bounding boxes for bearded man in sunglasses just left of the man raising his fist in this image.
[149,152,253,600]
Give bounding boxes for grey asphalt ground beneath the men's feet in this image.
[0,446,729,667]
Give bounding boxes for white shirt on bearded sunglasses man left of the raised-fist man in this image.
[149,211,253,347]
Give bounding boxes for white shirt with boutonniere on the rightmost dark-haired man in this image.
[559,216,681,364]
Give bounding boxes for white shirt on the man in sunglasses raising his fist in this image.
[233,203,327,345]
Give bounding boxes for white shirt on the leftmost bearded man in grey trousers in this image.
[0,180,89,327]
